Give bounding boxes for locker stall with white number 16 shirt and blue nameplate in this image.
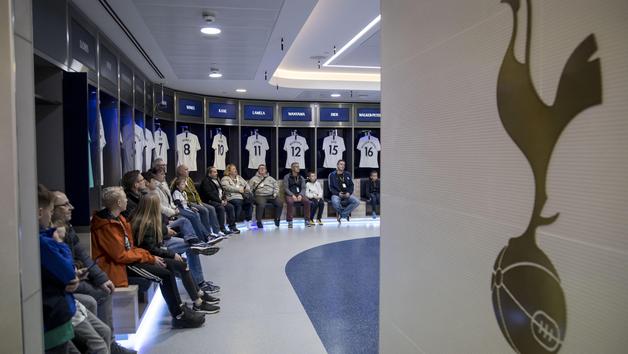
[353,104,381,178]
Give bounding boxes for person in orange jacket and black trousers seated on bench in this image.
[90,187,205,328]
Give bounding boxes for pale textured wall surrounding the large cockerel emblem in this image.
[380,0,628,354]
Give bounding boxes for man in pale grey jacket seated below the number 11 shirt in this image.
[249,165,283,228]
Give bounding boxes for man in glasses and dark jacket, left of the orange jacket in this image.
[52,191,137,354]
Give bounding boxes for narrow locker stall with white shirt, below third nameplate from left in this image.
[120,58,144,174]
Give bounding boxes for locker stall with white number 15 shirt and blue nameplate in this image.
[316,103,353,180]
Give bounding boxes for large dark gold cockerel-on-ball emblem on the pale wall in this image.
[491,0,602,354]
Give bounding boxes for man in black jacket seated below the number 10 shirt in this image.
[198,166,240,234]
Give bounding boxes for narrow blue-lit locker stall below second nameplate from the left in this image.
[98,41,122,187]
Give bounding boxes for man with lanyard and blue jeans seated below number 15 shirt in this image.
[329,160,360,222]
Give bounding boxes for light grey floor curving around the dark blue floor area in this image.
[121,219,379,354]
